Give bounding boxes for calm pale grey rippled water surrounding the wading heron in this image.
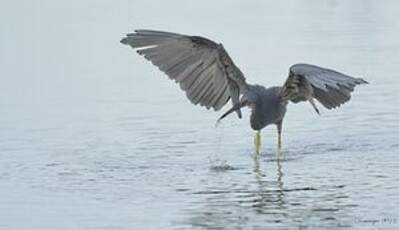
[0,0,399,230]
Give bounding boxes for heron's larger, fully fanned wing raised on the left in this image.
[121,30,247,117]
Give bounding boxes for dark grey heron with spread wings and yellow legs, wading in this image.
[121,30,367,154]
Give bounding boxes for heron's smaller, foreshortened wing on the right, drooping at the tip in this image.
[281,64,368,113]
